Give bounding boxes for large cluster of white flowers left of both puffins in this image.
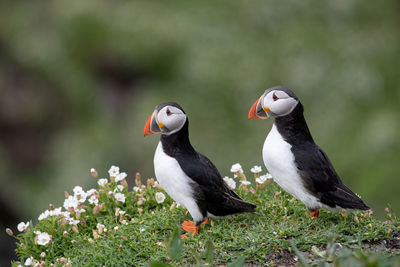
[10,165,173,266]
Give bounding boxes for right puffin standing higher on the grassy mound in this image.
[248,86,370,219]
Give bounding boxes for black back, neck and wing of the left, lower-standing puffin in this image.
[161,119,256,223]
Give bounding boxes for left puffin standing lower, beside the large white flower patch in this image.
[144,102,256,238]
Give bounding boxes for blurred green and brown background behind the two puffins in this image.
[0,0,400,264]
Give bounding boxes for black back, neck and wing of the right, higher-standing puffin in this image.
[275,101,369,210]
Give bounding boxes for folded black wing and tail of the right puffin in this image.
[292,144,369,210]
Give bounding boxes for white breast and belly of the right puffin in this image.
[263,124,322,209]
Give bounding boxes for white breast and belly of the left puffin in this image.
[154,142,203,222]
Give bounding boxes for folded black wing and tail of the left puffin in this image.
[176,152,256,216]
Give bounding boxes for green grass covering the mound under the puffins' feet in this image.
[9,169,400,266]
